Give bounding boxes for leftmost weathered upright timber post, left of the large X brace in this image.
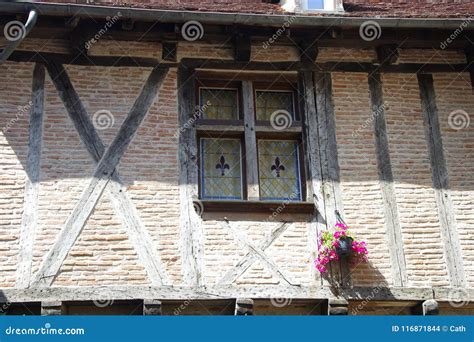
[16,64,45,288]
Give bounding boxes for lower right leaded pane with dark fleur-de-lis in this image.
[258,140,301,201]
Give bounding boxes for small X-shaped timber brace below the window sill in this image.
[219,221,295,285]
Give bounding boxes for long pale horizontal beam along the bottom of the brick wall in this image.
[0,285,436,303]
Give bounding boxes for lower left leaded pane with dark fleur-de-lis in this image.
[201,138,242,200]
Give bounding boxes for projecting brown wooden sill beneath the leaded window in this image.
[194,200,315,221]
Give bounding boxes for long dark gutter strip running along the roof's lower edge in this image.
[0,2,474,30]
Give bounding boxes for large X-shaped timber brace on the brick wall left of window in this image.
[33,61,169,287]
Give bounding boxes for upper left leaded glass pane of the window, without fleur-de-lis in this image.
[200,88,239,120]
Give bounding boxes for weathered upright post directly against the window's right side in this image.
[298,71,327,285]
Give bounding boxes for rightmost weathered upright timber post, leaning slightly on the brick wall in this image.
[417,75,467,287]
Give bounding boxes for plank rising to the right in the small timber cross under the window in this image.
[218,222,290,285]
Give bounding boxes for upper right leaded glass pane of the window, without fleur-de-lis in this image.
[255,91,294,121]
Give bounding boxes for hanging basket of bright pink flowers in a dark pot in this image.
[315,222,368,273]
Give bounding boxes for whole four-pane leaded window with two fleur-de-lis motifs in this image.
[196,75,305,202]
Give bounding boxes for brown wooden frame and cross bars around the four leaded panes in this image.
[195,76,314,213]
